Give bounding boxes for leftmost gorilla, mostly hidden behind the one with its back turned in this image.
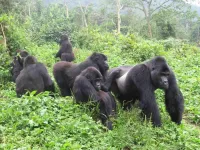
[10,50,29,82]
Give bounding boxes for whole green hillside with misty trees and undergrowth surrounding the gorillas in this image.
[0,0,200,150]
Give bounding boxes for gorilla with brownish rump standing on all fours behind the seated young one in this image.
[53,53,119,96]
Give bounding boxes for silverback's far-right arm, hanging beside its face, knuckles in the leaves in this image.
[165,71,184,124]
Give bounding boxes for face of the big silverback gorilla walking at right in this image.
[151,65,170,90]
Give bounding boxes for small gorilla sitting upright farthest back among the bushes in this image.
[56,35,75,62]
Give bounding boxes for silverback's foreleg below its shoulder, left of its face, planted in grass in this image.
[133,64,161,126]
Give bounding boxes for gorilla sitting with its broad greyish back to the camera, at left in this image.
[16,56,55,97]
